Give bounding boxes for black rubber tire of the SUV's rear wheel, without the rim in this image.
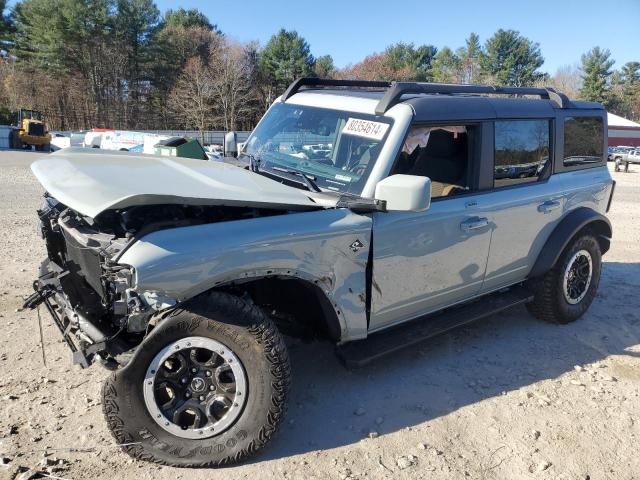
[527,232,602,324]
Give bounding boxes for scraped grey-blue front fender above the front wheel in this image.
[118,209,372,341]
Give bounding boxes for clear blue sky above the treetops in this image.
[156,0,640,74]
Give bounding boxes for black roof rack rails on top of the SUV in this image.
[282,78,571,115]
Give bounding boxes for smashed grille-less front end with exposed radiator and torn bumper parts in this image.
[24,196,182,368]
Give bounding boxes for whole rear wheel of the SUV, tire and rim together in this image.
[527,233,602,323]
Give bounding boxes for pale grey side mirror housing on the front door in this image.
[375,174,431,212]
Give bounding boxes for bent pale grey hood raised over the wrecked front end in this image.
[31,148,323,218]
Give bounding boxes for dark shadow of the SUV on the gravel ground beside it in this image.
[253,262,640,462]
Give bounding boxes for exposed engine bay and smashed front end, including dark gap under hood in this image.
[25,194,287,368]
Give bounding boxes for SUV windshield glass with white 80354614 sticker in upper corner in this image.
[242,103,391,194]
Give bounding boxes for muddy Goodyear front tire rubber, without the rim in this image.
[102,292,290,467]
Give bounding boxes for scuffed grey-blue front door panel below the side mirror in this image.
[369,195,492,331]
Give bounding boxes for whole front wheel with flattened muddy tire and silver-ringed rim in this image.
[103,293,290,467]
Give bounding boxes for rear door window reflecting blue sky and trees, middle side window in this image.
[493,120,551,188]
